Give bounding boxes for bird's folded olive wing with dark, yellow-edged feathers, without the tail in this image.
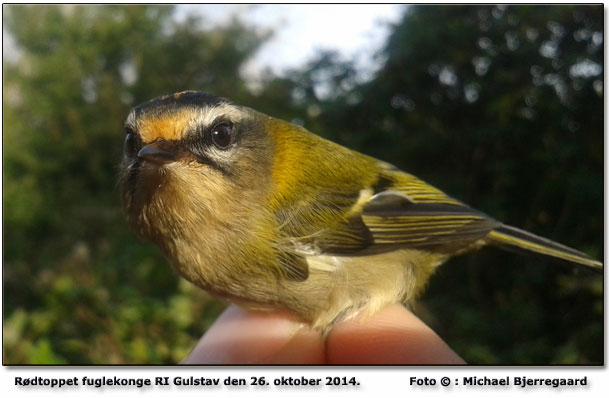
[276,168,500,276]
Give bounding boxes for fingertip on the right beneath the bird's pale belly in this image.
[326,304,465,365]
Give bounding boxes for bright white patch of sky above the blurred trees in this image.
[176,4,404,77]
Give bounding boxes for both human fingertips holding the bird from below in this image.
[183,304,465,365]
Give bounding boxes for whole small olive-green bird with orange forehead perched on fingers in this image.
[120,91,603,332]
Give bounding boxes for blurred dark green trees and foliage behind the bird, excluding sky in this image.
[3,5,604,364]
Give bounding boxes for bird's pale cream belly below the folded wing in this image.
[282,250,445,330]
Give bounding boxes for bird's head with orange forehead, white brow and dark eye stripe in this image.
[120,91,273,240]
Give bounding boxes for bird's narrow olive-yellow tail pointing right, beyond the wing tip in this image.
[488,225,603,269]
